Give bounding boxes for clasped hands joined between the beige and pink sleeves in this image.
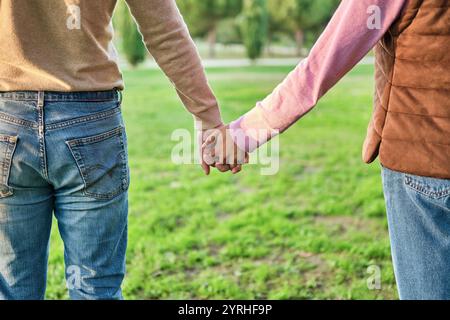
[202,126,248,174]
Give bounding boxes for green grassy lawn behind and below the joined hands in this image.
[47,66,397,299]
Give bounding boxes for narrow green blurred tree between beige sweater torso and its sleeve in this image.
[114,1,147,67]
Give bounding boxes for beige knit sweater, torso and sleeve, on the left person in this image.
[0,0,221,128]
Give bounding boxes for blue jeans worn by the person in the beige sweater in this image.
[0,91,129,299]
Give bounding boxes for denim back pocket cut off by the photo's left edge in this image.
[0,135,17,198]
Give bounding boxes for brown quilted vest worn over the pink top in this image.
[363,0,450,179]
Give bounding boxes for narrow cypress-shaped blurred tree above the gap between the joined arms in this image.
[241,0,268,60]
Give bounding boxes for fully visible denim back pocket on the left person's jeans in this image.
[66,126,130,200]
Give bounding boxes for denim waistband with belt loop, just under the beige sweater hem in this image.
[0,89,122,102]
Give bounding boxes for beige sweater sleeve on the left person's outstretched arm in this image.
[126,0,222,129]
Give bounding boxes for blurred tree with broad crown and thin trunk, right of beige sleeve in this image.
[177,0,242,58]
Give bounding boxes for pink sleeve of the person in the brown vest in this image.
[230,0,408,152]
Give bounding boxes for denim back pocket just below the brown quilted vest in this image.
[405,174,450,200]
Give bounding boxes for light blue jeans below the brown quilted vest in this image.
[383,168,450,300]
